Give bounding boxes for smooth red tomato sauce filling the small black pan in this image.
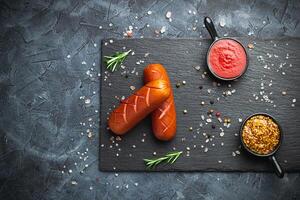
[208,39,247,79]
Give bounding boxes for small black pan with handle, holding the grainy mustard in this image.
[240,113,284,178]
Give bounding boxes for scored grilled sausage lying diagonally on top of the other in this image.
[108,80,171,135]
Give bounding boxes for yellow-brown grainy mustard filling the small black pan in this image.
[242,115,281,155]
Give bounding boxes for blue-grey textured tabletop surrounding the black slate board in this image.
[0,0,300,200]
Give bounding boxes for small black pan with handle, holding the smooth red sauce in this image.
[204,17,249,81]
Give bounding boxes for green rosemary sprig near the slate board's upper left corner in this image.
[104,50,131,72]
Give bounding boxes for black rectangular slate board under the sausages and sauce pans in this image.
[99,38,300,172]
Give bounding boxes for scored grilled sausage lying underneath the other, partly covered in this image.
[144,64,176,141]
